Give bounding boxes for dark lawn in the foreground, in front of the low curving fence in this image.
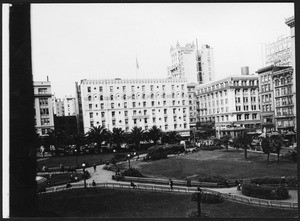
[38,188,297,218]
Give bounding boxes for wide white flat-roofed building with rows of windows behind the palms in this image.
[77,78,190,136]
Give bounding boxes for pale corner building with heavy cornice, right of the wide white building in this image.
[196,75,260,138]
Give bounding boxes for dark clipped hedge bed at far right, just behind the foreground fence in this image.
[242,183,290,200]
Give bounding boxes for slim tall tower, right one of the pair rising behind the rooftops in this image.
[197,45,215,84]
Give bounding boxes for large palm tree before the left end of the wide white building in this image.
[87,126,109,153]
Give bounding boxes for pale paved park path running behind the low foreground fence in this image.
[78,162,298,203]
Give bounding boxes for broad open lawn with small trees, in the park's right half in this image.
[133,149,297,180]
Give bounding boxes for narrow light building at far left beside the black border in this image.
[33,80,54,135]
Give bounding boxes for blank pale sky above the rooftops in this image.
[31,3,294,97]
